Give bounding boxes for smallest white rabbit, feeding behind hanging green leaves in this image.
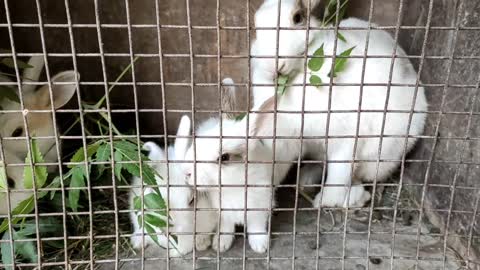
[130,116,217,257]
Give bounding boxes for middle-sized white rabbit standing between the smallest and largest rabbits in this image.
[184,79,289,253]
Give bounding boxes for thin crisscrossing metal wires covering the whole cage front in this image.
[0,0,480,269]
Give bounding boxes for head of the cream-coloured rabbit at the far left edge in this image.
[0,71,78,167]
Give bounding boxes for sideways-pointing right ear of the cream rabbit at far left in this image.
[35,70,80,109]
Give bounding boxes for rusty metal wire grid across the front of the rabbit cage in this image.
[0,0,480,269]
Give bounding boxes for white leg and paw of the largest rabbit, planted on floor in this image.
[314,141,370,207]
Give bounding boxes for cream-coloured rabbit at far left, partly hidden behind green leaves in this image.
[0,56,79,214]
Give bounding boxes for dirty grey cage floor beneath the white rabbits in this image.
[100,188,463,270]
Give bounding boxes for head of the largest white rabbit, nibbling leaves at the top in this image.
[251,0,321,74]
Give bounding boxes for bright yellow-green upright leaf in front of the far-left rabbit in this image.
[23,139,48,189]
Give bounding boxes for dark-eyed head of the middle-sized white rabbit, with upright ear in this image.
[184,80,271,190]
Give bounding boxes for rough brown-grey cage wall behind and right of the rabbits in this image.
[0,0,480,266]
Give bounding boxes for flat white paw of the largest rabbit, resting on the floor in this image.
[314,186,371,207]
